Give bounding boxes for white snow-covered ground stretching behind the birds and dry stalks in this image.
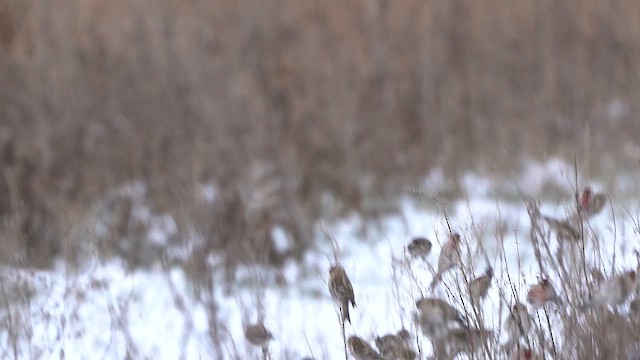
[0,161,640,359]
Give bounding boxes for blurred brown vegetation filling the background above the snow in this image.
[0,0,640,272]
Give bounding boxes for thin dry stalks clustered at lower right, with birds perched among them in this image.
[332,190,640,359]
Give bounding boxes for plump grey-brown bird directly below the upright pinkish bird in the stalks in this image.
[415,298,465,338]
